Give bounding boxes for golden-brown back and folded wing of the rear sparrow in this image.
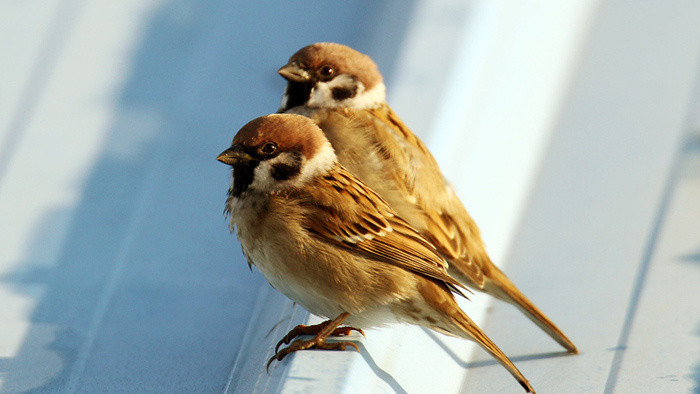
[322,105,491,288]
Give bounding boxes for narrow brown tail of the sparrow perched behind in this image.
[486,267,578,354]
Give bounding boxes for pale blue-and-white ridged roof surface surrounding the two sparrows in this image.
[0,0,700,393]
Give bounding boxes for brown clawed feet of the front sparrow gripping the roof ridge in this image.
[267,312,365,371]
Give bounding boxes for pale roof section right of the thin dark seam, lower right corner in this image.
[615,136,700,393]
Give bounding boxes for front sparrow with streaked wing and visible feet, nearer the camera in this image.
[217,114,533,392]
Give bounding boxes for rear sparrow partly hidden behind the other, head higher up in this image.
[278,43,578,353]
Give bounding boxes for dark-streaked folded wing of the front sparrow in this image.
[292,166,464,295]
